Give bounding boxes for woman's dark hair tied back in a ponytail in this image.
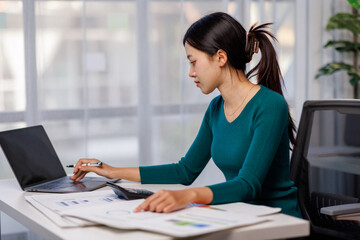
[183,12,296,145]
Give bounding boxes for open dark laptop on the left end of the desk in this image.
[0,125,119,193]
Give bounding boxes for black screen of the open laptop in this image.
[0,126,66,189]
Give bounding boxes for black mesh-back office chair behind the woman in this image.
[290,100,360,239]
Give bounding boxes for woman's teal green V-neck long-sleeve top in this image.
[140,85,301,217]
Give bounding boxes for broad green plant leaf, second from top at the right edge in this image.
[326,13,360,34]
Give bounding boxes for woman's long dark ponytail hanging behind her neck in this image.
[245,23,296,145]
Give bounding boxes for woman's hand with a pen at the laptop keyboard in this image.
[70,158,114,182]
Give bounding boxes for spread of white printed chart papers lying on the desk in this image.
[27,190,281,237]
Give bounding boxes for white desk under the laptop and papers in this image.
[0,179,310,240]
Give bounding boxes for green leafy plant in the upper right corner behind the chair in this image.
[315,0,360,98]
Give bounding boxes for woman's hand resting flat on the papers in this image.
[134,188,196,213]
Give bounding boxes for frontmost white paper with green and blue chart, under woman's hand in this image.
[61,200,268,237]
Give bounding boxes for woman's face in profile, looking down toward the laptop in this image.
[185,43,221,94]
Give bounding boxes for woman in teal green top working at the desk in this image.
[71,12,301,217]
